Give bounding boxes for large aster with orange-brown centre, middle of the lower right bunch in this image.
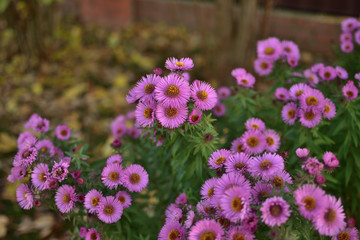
[220,187,251,223]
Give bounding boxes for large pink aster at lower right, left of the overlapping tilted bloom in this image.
[294,184,325,220]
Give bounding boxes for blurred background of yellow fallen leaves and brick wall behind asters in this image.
[0,0,360,239]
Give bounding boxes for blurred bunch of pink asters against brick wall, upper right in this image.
[254,37,300,76]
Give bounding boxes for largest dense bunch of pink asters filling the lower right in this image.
[158,124,358,240]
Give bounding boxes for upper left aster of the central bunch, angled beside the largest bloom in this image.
[134,74,161,102]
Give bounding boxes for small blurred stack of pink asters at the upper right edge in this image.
[340,17,360,53]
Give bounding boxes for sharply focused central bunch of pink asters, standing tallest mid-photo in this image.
[126,58,217,129]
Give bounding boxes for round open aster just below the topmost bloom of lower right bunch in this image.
[241,130,266,154]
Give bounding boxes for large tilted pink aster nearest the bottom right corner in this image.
[313,195,346,236]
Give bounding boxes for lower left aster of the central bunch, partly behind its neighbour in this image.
[135,101,156,127]
